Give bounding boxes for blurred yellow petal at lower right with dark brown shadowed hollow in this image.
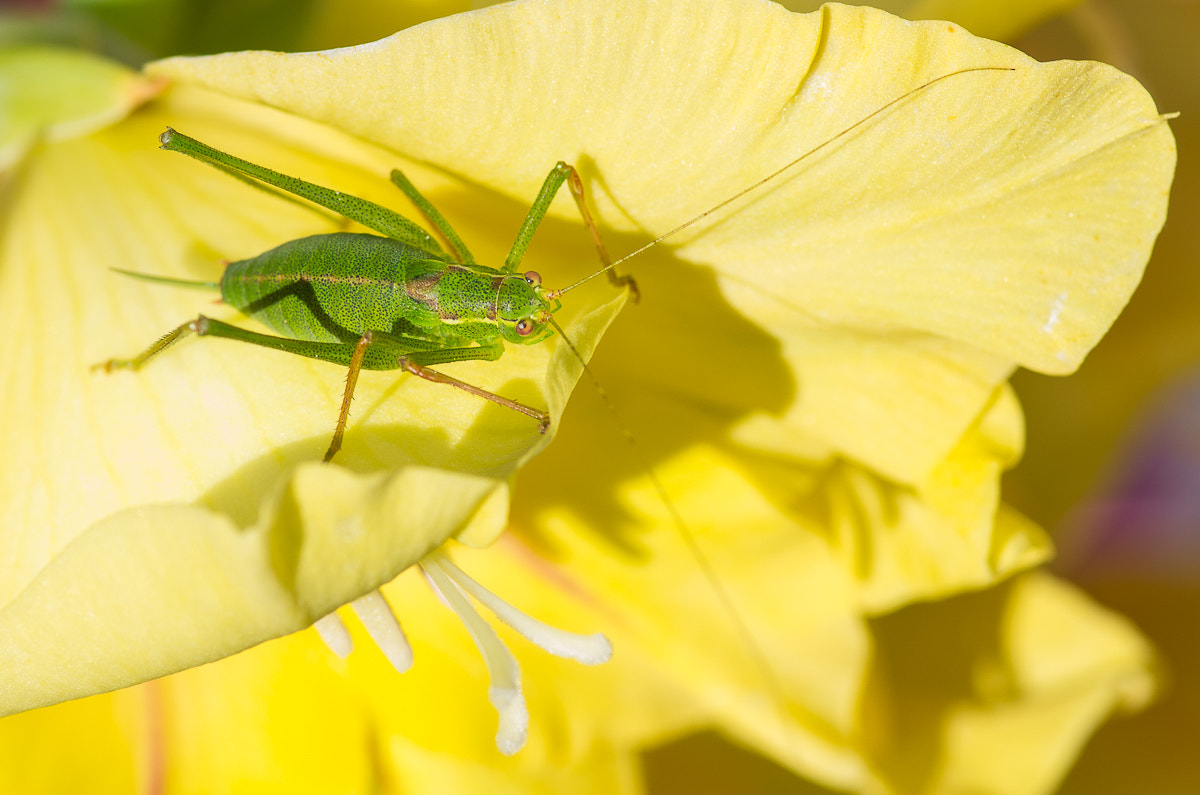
[863,574,1156,795]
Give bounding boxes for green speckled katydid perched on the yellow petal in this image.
[97,127,636,461]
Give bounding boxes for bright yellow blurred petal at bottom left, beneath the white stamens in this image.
[0,607,637,794]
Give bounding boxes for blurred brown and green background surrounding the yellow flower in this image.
[0,0,1200,795]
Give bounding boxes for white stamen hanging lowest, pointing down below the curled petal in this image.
[421,556,529,755]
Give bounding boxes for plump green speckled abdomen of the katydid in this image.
[221,232,432,342]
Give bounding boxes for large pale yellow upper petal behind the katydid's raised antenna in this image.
[151,2,1174,492]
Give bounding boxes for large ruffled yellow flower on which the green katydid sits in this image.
[0,1,1174,793]
